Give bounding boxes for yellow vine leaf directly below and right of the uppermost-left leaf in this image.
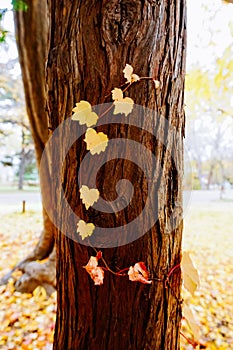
[84,128,108,154]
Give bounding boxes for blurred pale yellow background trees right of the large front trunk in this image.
[186,45,233,189]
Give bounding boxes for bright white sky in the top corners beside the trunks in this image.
[0,0,233,70]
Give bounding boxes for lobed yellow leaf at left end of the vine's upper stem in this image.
[71,100,98,127]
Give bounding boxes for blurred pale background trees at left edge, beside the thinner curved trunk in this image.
[0,59,35,190]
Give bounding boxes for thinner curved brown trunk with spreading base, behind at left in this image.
[1,0,56,293]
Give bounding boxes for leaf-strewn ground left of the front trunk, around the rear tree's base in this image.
[0,212,56,350]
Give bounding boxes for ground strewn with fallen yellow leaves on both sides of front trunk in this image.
[0,190,233,350]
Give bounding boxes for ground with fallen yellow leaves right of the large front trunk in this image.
[181,193,233,350]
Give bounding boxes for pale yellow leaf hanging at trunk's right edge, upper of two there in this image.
[181,252,200,295]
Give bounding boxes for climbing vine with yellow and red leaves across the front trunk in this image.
[71,64,199,348]
